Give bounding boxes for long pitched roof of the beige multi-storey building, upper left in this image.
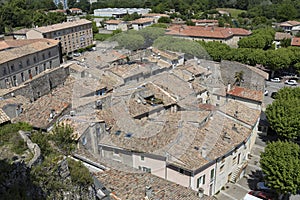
[34,19,92,33]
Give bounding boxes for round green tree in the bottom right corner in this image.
[260,141,300,194]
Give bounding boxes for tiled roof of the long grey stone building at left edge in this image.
[0,39,59,64]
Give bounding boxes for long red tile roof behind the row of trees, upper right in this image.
[166,25,251,39]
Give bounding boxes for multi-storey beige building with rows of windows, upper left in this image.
[26,19,93,54]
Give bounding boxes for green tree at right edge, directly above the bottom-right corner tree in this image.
[266,87,300,139]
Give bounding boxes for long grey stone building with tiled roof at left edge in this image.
[0,39,62,88]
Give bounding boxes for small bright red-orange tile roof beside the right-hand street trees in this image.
[227,86,263,102]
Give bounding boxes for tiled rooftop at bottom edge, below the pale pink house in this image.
[96,170,213,200]
